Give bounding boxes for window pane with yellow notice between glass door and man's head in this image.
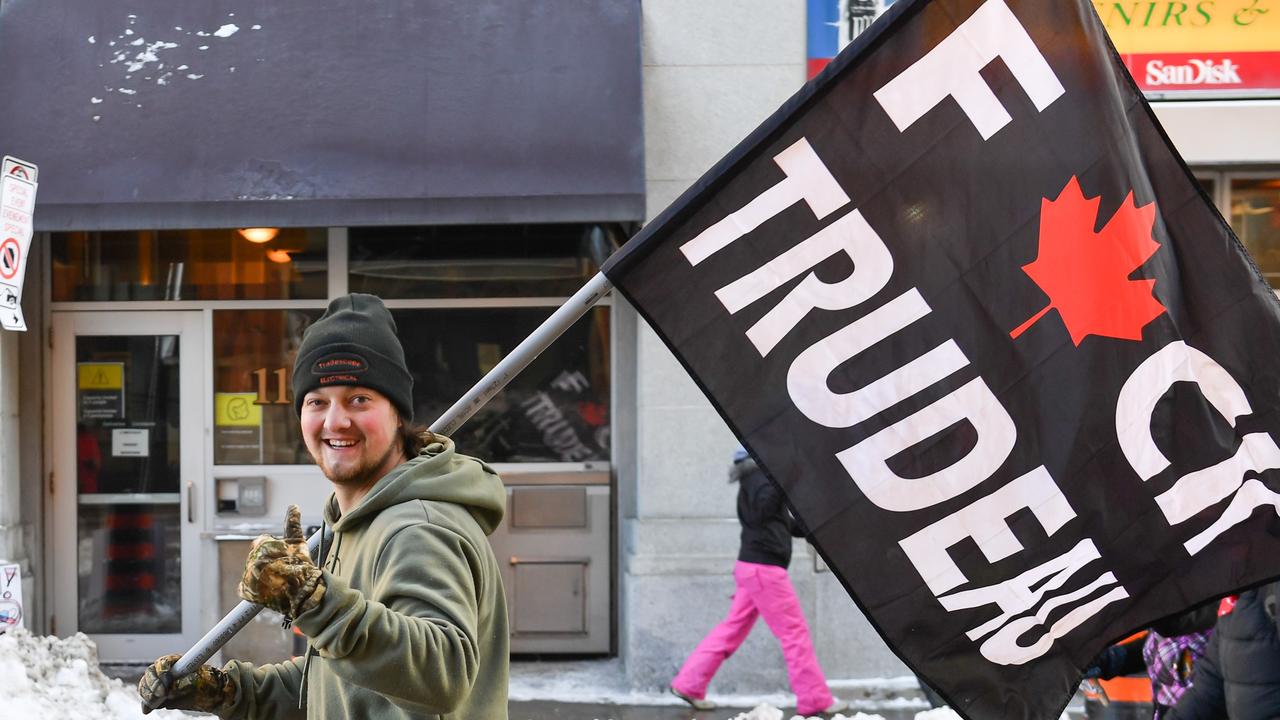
[212,309,323,465]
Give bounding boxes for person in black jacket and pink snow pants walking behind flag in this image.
[671,447,849,716]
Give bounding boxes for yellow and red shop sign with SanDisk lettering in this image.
[1093,0,1280,96]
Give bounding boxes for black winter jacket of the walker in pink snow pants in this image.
[731,457,805,568]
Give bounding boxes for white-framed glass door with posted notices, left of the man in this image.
[50,311,205,662]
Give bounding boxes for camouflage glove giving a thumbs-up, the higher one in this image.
[239,505,324,621]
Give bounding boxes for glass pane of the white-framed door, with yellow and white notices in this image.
[74,336,182,634]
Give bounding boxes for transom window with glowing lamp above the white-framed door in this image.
[52,228,328,302]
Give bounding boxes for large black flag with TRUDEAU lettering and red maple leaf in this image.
[604,0,1280,720]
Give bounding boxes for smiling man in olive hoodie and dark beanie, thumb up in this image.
[138,293,509,720]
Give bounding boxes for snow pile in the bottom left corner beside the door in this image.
[0,629,199,720]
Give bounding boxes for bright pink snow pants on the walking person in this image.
[671,561,835,715]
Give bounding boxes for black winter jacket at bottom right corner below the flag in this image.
[1166,583,1280,720]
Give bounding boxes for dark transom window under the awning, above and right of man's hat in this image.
[348,224,621,299]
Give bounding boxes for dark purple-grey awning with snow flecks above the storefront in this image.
[0,0,644,231]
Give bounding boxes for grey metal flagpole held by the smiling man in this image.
[170,273,613,679]
